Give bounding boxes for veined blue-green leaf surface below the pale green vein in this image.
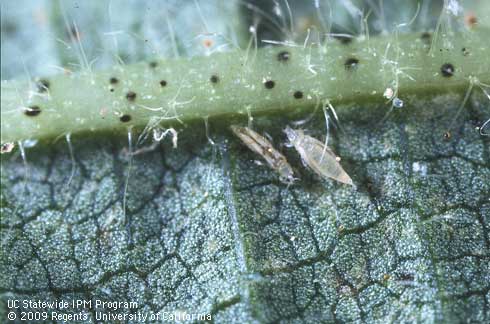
[0,0,490,323]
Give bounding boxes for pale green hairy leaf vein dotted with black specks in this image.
[1,29,490,143]
